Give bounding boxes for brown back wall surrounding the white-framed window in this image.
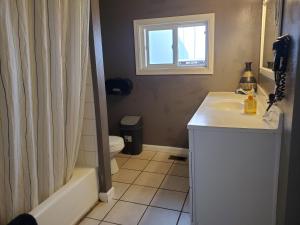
[100,0,262,147]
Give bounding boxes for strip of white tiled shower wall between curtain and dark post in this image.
[76,68,98,167]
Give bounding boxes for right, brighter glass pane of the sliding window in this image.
[178,25,207,66]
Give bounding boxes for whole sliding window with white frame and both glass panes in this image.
[134,14,214,75]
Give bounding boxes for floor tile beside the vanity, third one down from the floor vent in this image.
[150,189,186,211]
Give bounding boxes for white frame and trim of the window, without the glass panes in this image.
[133,13,215,75]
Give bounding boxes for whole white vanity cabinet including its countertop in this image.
[188,93,282,225]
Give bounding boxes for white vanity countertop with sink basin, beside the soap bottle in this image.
[188,92,282,132]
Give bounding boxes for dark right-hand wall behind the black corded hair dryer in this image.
[260,0,300,225]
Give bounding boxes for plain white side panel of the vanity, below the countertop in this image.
[190,129,279,225]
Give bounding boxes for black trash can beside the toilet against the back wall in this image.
[120,116,143,155]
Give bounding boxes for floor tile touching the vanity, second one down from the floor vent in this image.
[161,175,189,192]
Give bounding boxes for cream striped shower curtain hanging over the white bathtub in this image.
[0,0,90,225]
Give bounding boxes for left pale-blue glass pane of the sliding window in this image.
[148,30,173,65]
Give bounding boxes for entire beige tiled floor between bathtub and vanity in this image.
[79,151,191,225]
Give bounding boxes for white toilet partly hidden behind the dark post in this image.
[109,136,125,174]
